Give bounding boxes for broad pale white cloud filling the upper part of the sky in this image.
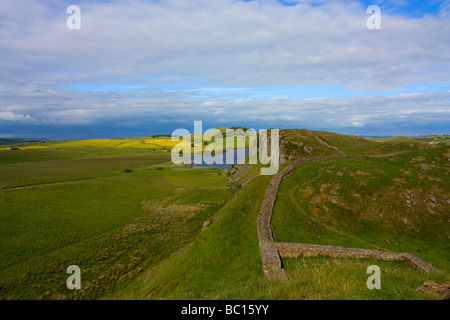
[0,0,450,90]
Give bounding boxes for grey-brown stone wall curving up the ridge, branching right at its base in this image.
[257,152,441,281]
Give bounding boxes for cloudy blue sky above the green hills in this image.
[0,0,450,139]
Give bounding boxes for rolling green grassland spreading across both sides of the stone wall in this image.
[0,130,450,299]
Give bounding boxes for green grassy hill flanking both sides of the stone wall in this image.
[106,130,450,299]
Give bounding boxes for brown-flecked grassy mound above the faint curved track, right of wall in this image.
[274,148,450,248]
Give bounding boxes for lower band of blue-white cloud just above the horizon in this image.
[0,86,450,128]
